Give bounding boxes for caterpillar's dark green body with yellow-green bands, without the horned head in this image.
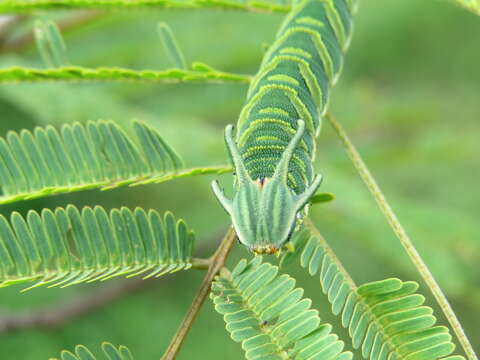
[237,0,353,194]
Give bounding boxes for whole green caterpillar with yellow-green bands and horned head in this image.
[212,0,356,254]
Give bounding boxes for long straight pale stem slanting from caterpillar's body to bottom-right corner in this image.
[326,114,478,360]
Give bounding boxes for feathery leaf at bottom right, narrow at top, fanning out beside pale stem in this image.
[282,227,463,360]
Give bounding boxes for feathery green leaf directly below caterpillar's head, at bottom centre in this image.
[211,257,352,360]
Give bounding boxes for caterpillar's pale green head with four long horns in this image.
[212,120,322,254]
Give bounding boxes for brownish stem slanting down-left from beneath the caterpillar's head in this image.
[161,228,236,360]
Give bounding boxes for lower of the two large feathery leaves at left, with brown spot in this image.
[0,205,194,287]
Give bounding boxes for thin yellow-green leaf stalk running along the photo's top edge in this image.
[0,0,290,14]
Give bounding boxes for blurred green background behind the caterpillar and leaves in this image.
[0,0,480,360]
